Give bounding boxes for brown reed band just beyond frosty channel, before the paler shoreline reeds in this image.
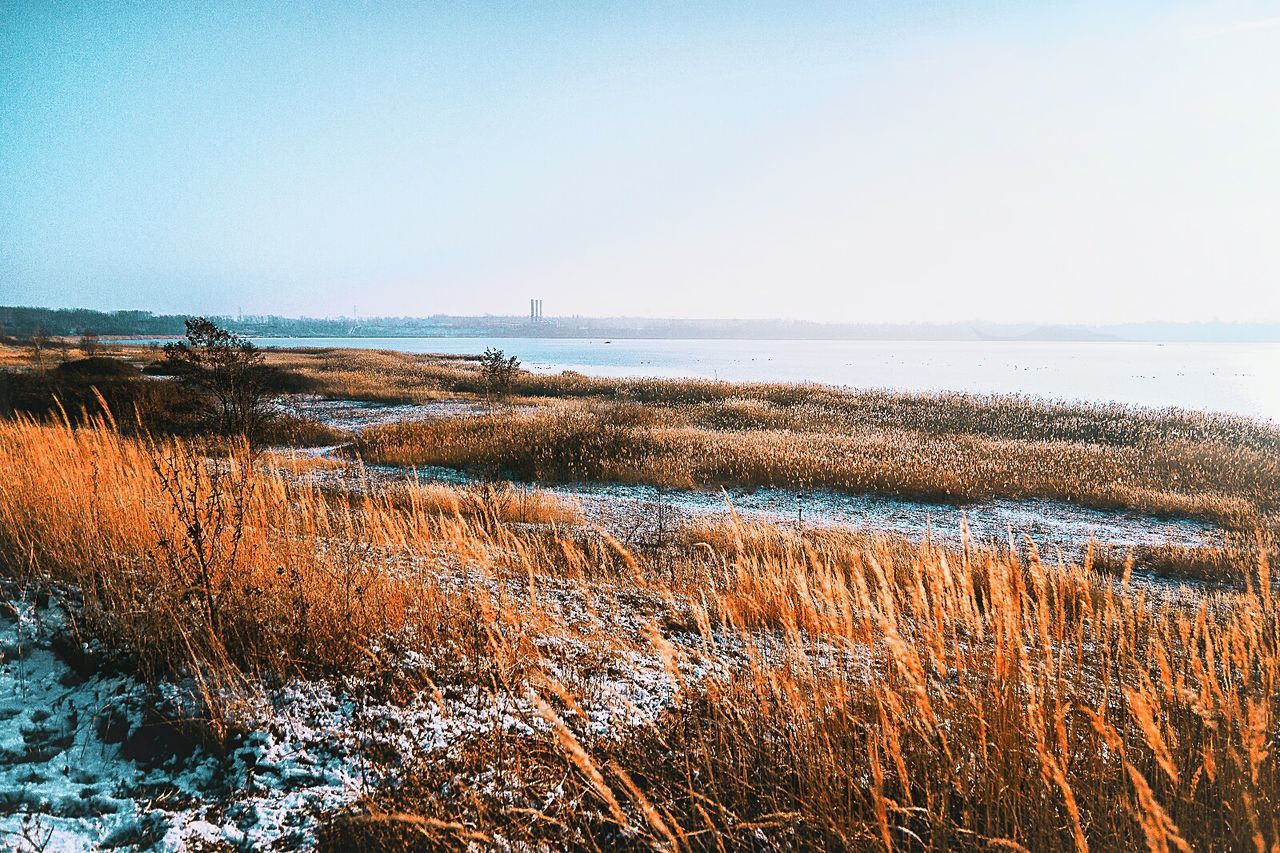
[361,397,1280,530]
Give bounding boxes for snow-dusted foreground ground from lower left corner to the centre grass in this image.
[0,573,691,850]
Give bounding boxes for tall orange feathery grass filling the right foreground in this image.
[343,512,1280,850]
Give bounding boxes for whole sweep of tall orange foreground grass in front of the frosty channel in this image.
[0,420,1280,852]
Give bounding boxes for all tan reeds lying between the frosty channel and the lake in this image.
[15,347,1280,533]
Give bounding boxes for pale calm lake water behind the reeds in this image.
[202,338,1280,421]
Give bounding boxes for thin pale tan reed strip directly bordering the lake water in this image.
[147,347,1280,452]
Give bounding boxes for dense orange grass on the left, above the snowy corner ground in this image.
[0,419,545,721]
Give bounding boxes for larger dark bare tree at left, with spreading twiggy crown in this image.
[164,316,273,435]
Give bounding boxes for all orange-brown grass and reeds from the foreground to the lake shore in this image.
[0,338,1280,850]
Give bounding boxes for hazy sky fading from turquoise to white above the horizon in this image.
[0,0,1280,323]
